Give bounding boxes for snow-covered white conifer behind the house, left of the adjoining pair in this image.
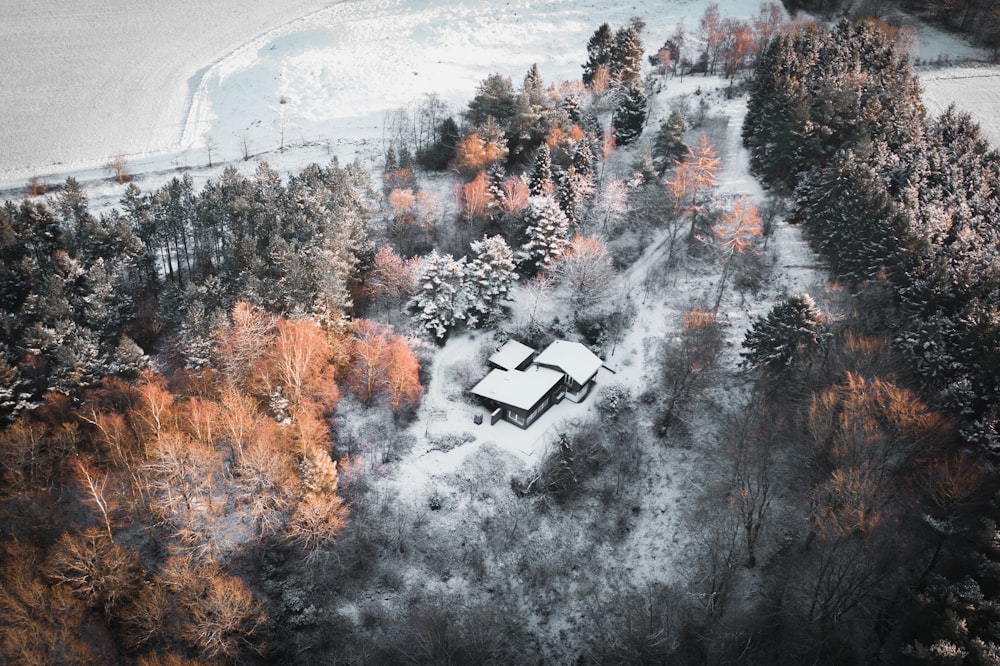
[410,250,469,341]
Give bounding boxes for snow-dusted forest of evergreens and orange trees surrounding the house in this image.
[0,2,1000,666]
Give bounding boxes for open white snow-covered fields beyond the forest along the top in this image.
[0,0,1000,195]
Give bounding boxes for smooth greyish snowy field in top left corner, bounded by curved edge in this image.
[0,0,330,182]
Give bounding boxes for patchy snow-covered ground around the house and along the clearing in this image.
[389,68,827,580]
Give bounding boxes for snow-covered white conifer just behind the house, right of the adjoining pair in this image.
[464,236,514,328]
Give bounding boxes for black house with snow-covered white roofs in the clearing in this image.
[471,340,604,428]
